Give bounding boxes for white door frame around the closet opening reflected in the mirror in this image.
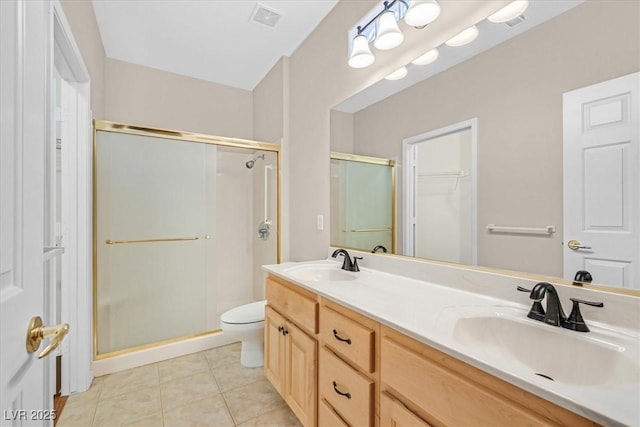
[402,117,478,265]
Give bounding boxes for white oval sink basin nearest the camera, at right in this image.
[440,308,640,386]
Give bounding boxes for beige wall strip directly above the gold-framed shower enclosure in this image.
[104,58,253,139]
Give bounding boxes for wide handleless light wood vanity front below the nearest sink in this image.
[380,326,597,426]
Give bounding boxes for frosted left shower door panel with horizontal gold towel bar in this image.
[95,132,216,355]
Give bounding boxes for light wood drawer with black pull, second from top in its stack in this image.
[318,347,374,426]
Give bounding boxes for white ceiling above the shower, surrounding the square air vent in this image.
[92,0,338,90]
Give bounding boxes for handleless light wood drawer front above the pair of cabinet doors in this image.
[266,277,318,335]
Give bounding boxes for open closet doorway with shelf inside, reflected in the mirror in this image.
[403,120,477,265]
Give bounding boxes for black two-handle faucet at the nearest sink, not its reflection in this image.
[518,282,604,332]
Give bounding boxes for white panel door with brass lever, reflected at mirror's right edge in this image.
[563,73,640,289]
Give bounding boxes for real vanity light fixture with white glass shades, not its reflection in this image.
[349,0,440,68]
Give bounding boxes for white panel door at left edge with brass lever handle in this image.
[0,0,53,426]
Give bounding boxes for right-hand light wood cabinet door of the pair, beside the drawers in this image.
[285,322,318,426]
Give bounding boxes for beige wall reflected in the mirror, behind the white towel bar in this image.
[354,1,640,276]
